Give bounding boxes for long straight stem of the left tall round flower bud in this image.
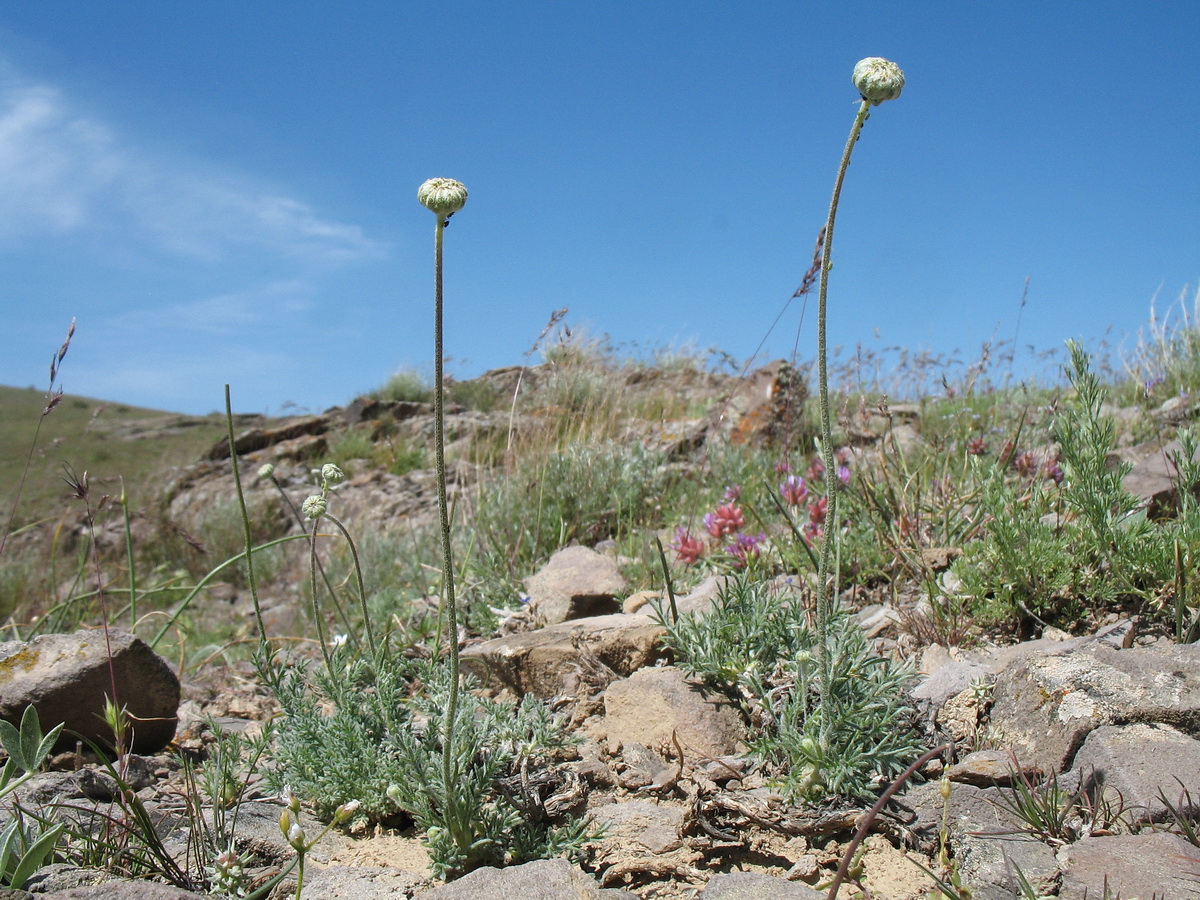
[433,215,458,816]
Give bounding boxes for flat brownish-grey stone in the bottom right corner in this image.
[1058,832,1200,900]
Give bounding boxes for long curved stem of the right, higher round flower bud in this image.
[816,100,871,628]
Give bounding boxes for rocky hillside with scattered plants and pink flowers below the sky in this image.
[0,361,1200,900]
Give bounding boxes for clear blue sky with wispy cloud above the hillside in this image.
[0,0,1200,413]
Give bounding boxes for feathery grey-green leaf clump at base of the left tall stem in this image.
[268,648,592,877]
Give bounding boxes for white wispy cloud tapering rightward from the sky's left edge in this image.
[0,73,383,264]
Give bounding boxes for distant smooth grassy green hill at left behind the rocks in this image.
[0,385,264,528]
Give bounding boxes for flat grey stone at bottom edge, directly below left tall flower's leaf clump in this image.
[418,859,637,900]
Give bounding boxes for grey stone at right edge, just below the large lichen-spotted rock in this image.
[1073,722,1200,822]
